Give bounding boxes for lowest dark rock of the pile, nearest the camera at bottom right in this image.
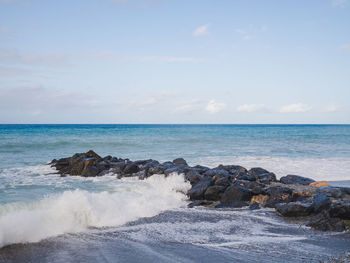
[307,211,345,232]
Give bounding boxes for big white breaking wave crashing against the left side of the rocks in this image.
[0,175,190,247]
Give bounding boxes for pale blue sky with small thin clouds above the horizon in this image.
[0,0,350,124]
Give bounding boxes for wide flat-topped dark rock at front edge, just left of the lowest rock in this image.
[276,202,313,217]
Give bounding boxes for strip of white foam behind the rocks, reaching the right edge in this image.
[197,156,350,181]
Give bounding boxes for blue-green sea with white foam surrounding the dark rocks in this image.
[0,124,350,263]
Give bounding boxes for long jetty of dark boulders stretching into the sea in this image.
[50,150,350,231]
